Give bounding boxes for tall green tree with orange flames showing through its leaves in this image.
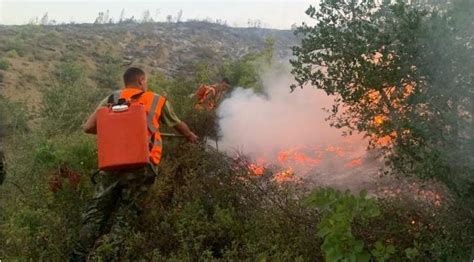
[291,0,474,195]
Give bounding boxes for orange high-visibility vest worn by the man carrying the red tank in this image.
[105,88,166,165]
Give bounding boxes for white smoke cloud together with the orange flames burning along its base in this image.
[218,65,446,205]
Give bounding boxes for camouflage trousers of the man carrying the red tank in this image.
[69,166,156,261]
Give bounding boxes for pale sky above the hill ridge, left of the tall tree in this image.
[0,0,318,29]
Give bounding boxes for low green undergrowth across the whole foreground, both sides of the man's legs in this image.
[0,134,472,261]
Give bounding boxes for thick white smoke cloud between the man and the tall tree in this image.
[217,65,380,188]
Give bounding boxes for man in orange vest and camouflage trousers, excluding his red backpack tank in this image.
[69,67,198,261]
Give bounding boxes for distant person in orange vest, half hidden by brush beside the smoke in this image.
[194,78,230,111]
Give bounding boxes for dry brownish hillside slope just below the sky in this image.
[0,22,296,103]
